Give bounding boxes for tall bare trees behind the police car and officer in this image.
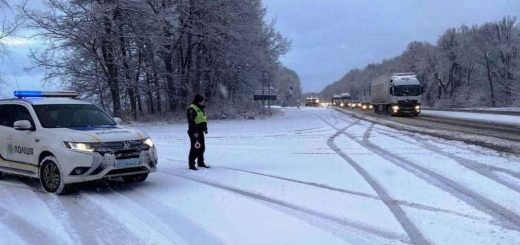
[20,0,296,118]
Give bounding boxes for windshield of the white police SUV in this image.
[34,104,116,128]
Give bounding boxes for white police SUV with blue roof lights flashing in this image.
[0,91,157,194]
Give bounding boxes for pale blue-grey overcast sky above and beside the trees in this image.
[0,0,520,97]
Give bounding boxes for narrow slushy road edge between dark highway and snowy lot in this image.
[335,108,520,154]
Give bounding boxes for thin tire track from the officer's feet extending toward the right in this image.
[214,166,485,221]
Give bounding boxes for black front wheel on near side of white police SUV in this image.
[40,156,69,195]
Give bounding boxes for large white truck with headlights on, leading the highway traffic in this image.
[371,73,422,116]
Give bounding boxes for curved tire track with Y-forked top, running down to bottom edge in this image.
[316,115,430,244]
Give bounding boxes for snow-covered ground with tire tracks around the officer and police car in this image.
[0,108,520,244]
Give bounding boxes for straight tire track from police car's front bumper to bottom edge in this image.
[159,171,410,243]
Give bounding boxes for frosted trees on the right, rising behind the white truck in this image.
[322,17,520,107]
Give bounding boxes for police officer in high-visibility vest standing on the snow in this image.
[186,94,209,170]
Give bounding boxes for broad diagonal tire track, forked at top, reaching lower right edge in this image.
[329,112,520,230]
